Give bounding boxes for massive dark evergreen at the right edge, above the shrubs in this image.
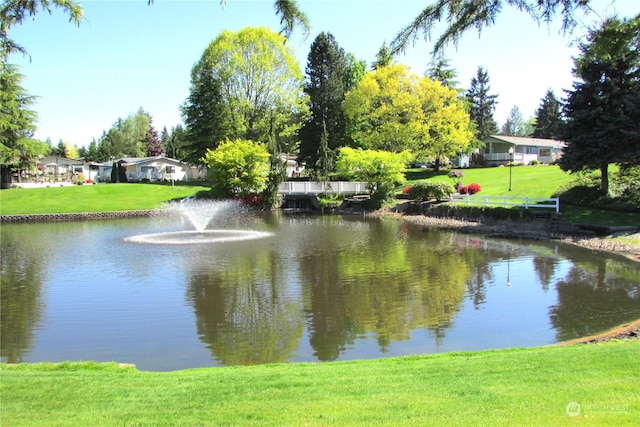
[559,15,640,193]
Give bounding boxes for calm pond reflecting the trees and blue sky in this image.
[0,212,640,371]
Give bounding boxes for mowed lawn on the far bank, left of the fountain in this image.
[0,184,209,215]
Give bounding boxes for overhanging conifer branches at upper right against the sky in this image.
[391,0,604,53]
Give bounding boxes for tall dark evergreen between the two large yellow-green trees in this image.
[300,33,356,176]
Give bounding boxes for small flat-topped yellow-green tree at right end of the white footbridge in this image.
[336,147,411,207]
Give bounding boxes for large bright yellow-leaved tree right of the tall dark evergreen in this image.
[343,64,473,170]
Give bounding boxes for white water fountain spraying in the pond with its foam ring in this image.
[125,199,272,245]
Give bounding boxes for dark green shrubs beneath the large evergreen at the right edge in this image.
[552,166,640,212]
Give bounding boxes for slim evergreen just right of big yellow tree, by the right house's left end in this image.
[467,67,498,140]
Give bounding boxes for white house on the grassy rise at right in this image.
[472,135,566,166]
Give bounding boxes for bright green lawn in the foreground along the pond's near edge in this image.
[0,341,640,426]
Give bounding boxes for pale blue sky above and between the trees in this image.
[10,0,640,147]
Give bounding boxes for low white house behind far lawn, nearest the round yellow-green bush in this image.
[98,156,207,182]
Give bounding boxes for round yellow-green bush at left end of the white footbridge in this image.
[204,139,269,196]
